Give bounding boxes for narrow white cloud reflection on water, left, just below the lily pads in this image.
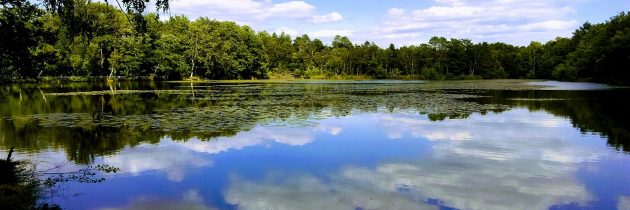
[94,122,342,182]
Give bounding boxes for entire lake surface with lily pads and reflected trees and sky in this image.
[0,81,630,209]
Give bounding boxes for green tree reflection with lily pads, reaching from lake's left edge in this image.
[0,83,507,163]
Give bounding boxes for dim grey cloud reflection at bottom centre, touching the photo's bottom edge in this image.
[225,175,437,210]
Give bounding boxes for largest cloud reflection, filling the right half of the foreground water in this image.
[226,109,608,210]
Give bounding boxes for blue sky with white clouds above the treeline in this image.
[165,0,630,46]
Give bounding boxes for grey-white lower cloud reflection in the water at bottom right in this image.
[342,158,591,210]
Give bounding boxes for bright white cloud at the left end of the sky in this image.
[163,0,354,41]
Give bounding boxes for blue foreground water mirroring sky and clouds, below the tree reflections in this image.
[42,109,630,209]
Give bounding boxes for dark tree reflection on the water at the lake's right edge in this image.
[470,89,630,152]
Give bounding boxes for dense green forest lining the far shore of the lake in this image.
[0,0,630,84]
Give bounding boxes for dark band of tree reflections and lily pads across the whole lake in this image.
[0,83,630,164]
